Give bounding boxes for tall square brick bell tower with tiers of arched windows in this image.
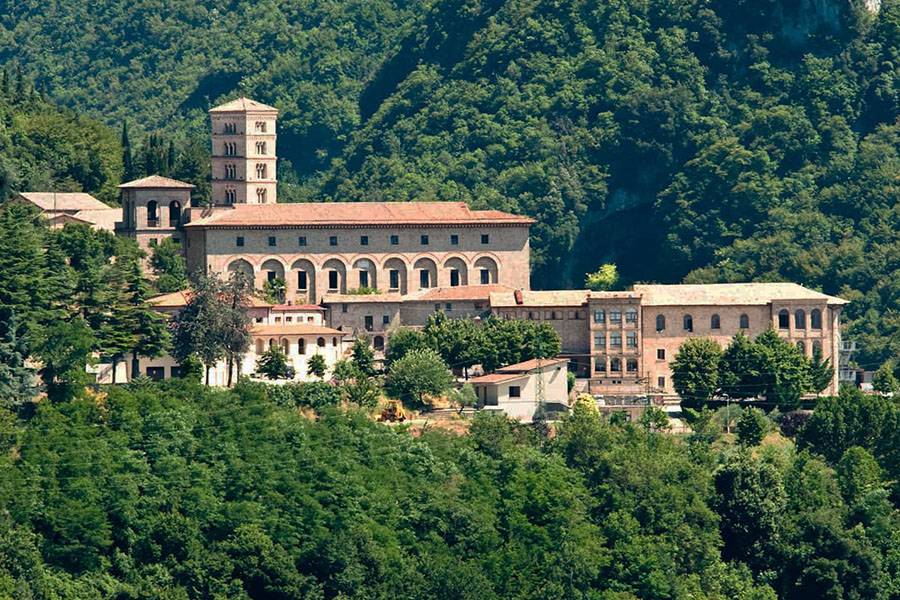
[209,98,278,206]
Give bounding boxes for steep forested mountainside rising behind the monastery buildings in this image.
[8,0,900,365]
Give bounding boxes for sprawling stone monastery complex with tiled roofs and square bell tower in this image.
[79,98,846,398]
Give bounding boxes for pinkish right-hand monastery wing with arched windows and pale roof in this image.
[490,283,846,396]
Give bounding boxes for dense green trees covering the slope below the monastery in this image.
[0,379,900,600]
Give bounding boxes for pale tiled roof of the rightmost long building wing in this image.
[633,282,848,306]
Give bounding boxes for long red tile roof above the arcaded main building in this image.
[186,202,535,228]
